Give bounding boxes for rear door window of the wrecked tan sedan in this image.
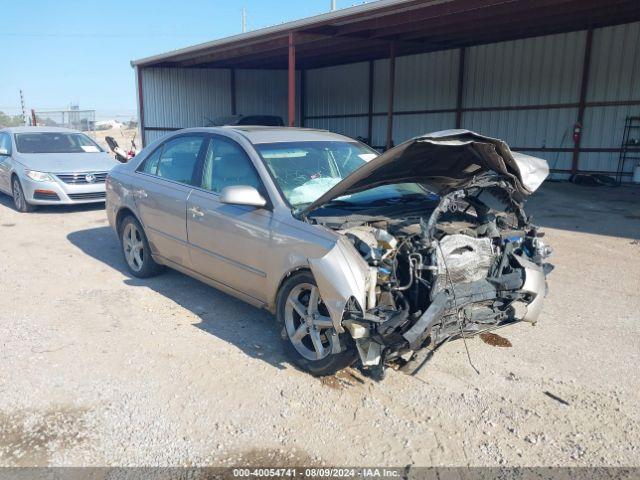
[142,135,204,186]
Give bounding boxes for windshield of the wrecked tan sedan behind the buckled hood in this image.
[256,141,378,207]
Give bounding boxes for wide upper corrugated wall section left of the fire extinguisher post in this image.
[464,31,586,107]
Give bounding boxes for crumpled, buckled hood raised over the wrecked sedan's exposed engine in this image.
[303,130,549,213]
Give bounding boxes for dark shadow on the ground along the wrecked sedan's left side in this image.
[67,227,289,369]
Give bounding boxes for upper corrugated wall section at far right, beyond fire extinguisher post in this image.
[587,22,640,102]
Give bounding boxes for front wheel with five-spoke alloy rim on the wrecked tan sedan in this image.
[276,272,356,376]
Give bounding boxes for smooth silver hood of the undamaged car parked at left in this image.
[15,152,119,173]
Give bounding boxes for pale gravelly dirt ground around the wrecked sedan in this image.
[0,183,640,466]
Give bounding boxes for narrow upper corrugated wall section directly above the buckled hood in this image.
[396,49,460,112]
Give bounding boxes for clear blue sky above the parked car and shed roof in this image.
[0,0,363,119]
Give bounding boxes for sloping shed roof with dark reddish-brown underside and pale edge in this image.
[132,0,640,68]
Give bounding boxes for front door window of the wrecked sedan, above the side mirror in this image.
[201,137,261,193]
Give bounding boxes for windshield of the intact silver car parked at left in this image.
[16,132,102,153]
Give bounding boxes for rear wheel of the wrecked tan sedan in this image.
[120,215,163,278]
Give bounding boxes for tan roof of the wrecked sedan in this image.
[175,125,353,145]
